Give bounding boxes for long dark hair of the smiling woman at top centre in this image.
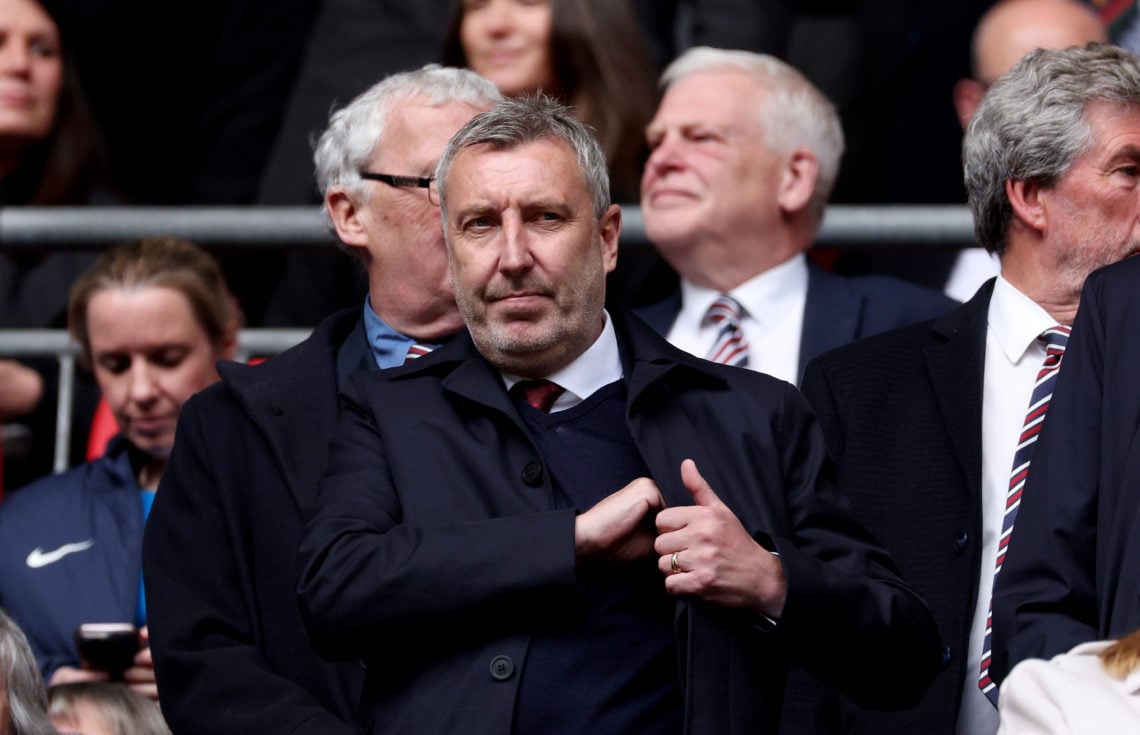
[442,0,657,202]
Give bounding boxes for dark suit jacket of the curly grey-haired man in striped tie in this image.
[787,280,993,735]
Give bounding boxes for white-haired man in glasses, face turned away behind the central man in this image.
[144,65,499,735]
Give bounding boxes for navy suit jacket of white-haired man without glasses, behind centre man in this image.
[634,262,958,375]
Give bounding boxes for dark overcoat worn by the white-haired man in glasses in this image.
[144,308,375,734]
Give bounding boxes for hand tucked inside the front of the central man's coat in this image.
[573,477,665,562]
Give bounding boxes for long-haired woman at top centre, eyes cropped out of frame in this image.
[443,0,657,203]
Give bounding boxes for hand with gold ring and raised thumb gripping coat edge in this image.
[653,459,788,618]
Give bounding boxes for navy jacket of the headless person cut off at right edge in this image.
[991,258,1140,681]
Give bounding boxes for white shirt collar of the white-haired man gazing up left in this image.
[681,253,807,326]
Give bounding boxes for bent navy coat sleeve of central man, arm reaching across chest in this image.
[298,379,577,659]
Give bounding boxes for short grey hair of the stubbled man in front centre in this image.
[435,93,610,220]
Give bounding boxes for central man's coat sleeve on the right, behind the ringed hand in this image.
[773,386,942,709]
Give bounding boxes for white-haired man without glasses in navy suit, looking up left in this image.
[637,48,956,383]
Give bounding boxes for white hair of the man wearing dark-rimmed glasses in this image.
[312,64,502,217]
